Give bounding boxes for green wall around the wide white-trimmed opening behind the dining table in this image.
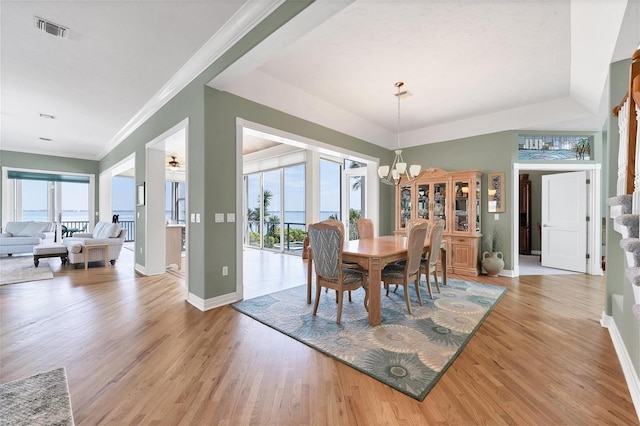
[204,87,394,298]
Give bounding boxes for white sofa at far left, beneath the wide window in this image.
[0,221,56,256]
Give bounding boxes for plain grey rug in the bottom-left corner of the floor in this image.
[0,367,74,426]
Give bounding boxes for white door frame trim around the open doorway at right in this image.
[511,163,603,277]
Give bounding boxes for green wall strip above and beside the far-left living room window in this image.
[0,151,100,224]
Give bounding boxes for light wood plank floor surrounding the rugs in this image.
[0,250,638,425]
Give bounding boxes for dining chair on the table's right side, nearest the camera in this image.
[381,222,429,314]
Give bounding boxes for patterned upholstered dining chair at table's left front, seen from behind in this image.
[308,221,367,324]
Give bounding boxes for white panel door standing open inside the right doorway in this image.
[542,171,587,272]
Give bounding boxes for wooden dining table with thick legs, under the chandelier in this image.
[307,235,446,325]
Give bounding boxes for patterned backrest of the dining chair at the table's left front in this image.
[308,221,344,280]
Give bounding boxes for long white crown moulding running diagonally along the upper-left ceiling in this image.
[99,0,284,159]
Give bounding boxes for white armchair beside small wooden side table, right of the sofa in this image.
[62,222,127,266]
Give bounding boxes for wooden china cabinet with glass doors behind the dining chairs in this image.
[395,168,482,276]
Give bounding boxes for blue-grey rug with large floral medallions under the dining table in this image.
[233,278,506,401]
